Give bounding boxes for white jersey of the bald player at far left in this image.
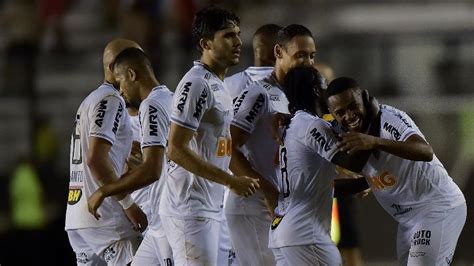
[66,83,132,230]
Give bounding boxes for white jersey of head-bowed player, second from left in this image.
[139,86,173,237]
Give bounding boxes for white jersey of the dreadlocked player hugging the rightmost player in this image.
[269,111,338,248]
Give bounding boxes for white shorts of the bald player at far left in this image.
[67,228,141,266]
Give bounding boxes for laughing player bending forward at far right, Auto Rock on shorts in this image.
[327,77,466,265]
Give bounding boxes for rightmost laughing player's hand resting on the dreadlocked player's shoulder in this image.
[337,132,378,154]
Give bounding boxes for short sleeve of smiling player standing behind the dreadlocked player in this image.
[232,85,268,133]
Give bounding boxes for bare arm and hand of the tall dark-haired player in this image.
[168,122,259,196]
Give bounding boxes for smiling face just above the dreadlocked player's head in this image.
[280,36,316,73]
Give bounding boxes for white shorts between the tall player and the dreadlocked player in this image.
[226,214,275,266]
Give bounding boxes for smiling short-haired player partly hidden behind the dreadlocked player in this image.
[225,24,316,265]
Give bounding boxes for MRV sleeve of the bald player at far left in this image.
[89,95,125,144]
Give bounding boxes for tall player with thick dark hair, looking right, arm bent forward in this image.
[160,7,259,265]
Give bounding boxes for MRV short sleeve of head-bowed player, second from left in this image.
[140,101,170,149]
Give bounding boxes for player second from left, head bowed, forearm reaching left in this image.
[88,48,173,265]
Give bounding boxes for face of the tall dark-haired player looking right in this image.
[210,24,242,67]
